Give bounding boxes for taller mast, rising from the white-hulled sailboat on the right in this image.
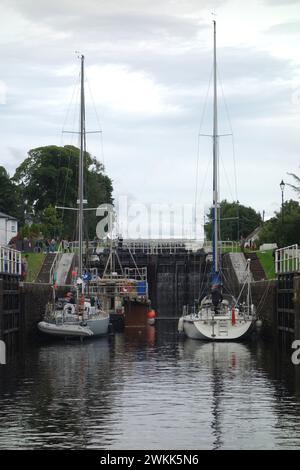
[213,21,219,273]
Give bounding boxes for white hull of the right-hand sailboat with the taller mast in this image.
[182,315,254,341]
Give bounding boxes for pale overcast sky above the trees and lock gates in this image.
[0,0,300,238]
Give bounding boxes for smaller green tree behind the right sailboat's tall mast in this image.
[204,199,262,241]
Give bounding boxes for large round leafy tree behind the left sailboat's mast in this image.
[13,145,112,239]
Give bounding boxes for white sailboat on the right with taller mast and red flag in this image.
[178,21,255,341]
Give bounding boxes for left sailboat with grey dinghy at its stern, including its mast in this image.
[38,55,109,338]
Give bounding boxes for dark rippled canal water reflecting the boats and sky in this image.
[0,321,300,450]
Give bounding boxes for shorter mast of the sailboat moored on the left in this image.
[78,55,85,277]
